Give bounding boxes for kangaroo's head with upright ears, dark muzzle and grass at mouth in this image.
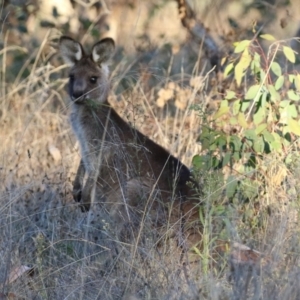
[59,36,115,104]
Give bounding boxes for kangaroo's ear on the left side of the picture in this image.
[59,36,84,66]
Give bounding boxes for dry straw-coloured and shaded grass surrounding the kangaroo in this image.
[0,1,300,300]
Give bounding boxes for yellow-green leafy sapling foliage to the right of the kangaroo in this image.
[193,34,300,232]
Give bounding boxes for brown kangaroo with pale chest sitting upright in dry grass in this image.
[59,36,199,241]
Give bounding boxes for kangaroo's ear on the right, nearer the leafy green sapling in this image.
[92,38,115,64]
